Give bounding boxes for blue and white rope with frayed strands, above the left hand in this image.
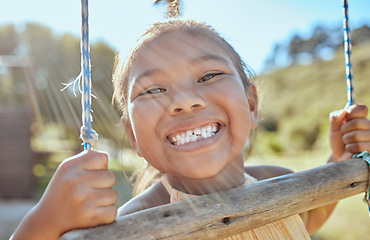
[80,0,98,150]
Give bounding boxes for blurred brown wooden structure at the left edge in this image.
[0,55,35,198]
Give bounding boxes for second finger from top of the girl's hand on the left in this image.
[85,170,116,188]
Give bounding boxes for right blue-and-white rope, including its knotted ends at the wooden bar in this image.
[343,0,370,214]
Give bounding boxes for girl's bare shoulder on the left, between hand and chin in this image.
[117,182,170,217]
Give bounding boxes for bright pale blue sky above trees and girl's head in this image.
[0,0,370,73]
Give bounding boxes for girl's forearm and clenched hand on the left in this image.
[11,151,118,240]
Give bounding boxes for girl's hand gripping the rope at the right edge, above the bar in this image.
[329,104,370,162]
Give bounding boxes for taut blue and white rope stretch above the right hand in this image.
[343,0,355,108]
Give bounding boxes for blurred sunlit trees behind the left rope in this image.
[0,23,119,146]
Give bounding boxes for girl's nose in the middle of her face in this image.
[169,88,206,115]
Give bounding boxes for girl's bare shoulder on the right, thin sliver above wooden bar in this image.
[244,165,293,180]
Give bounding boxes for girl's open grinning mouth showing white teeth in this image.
[167,122,220,146]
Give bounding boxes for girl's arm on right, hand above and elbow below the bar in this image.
[301,104,370,234]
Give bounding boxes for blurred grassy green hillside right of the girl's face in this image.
[254,42,370,154]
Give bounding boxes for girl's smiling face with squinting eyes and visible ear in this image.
[124,31,258,179]
